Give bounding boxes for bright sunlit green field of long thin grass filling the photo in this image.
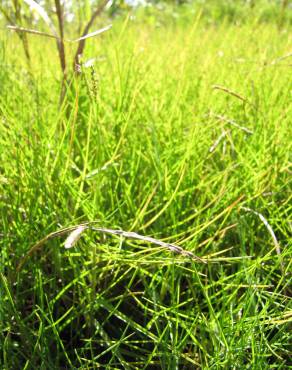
[0,4,292,369]
